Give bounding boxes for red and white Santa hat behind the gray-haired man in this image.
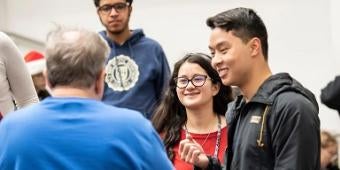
[25,51,46,75]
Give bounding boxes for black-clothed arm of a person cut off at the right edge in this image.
[320,76,340,114]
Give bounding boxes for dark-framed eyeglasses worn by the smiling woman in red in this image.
[175,74,208,89]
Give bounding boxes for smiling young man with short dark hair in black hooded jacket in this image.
[179,8,320,170]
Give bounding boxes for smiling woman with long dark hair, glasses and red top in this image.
[152,53,232,170]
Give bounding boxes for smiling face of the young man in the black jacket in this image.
[209,27,253,87]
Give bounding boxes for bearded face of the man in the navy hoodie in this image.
[97,0,132,35]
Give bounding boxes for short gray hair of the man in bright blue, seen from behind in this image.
[45,27,109,88]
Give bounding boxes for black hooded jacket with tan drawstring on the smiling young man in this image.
[205,73,320,170]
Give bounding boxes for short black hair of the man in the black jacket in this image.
[207,8,268,60]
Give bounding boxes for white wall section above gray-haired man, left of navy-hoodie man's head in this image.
[2,0,99,41]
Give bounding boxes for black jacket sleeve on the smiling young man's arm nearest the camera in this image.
[269,92,320,170]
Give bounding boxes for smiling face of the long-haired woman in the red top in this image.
[176,62,219,109]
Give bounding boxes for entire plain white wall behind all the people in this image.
[0,0,340,132]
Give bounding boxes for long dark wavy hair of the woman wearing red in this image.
[152,53,232,160]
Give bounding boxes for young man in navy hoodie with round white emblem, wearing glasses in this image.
[94,0,170,118]
